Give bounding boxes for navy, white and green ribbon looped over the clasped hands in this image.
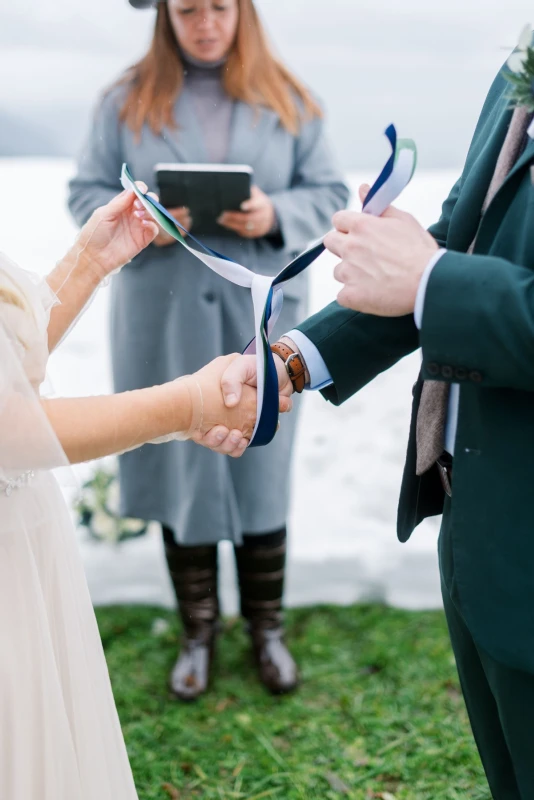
[121,125,417,447]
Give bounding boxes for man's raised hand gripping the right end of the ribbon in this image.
[324,187,438,317]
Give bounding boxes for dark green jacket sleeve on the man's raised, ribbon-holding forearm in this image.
[420,252,534,392]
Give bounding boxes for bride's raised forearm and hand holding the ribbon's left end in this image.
[46,188,158,352]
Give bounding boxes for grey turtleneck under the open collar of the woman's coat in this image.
[182,54,234,164]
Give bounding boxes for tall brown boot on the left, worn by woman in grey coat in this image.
[165,536,219,701]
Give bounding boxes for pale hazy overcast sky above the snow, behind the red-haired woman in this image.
[0,0,526,170]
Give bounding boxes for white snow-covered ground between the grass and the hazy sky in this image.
[0,159,457,612]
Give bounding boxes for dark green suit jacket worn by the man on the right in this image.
[300,69,534,672]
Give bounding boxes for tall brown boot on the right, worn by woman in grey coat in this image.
[235,528,299,694]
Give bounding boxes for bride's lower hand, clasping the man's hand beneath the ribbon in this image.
[184,353,292,458]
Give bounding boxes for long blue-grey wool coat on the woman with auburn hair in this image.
[69,81,348,545]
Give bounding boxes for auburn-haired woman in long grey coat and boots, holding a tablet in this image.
[69,0,348,700]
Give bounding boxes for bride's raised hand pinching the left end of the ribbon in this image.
[78,182,159,280]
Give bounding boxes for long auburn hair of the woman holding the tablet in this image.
[120,0,323,136]
